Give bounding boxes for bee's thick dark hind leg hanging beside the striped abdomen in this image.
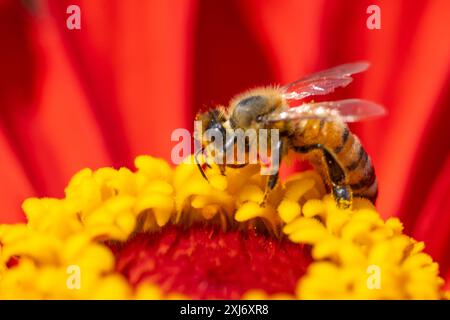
[294,143,352,209]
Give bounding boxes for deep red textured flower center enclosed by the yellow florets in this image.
[117,225,311,299]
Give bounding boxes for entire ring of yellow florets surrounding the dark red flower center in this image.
[0,156,442,299]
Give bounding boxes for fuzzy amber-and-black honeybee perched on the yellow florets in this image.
[196,62,385,208]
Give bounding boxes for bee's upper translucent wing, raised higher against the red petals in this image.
[281,62,369,100]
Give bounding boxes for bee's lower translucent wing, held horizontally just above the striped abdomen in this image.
[263,99,386,122]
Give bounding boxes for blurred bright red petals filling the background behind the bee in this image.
[0,0,450,288]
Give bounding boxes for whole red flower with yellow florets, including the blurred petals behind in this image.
[0,0,450,298]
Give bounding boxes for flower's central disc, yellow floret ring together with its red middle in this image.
[0,156,443,299]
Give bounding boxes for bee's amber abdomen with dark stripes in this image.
[292,120,378,202]
